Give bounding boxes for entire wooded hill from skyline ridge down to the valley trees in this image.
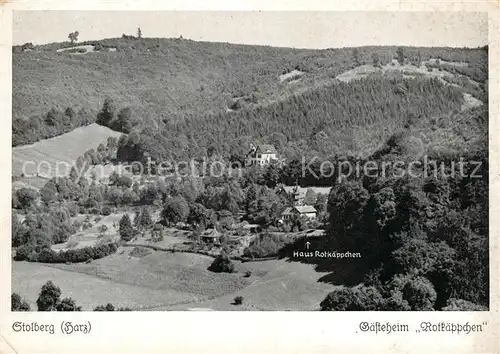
[13,36,487,160]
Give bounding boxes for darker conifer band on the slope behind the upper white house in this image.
[119,78,463,165]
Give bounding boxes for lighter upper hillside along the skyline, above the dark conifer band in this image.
[13,36,487,146]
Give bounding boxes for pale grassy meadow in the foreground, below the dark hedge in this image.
[12,248,333,310]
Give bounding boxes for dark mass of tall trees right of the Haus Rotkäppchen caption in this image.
[321,111,489,310]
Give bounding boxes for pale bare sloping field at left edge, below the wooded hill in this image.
[12,124,121,178]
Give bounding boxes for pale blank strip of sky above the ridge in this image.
[13,11,488,48]
